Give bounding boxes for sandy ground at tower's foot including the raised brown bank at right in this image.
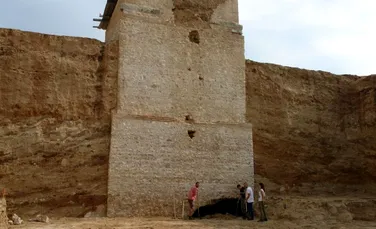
[7,196,376,229]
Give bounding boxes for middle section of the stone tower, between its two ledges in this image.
[118,19,245,123]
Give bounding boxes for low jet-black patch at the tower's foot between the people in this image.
[193,198,242,218]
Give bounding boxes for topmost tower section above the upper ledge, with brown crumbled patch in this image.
[106,0,241,41]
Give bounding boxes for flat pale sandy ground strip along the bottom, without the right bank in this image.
[11,218,376,229]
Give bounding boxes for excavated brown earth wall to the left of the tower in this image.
[0,29,117,216]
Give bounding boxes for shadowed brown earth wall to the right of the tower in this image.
[246,61,376,194]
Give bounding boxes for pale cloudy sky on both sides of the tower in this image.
[0,0,376,75]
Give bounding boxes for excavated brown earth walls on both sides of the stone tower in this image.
[0,29,376,216]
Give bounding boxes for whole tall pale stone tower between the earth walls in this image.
[99,0,253,217]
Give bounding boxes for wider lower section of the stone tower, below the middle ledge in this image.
[108,116,253,216]
